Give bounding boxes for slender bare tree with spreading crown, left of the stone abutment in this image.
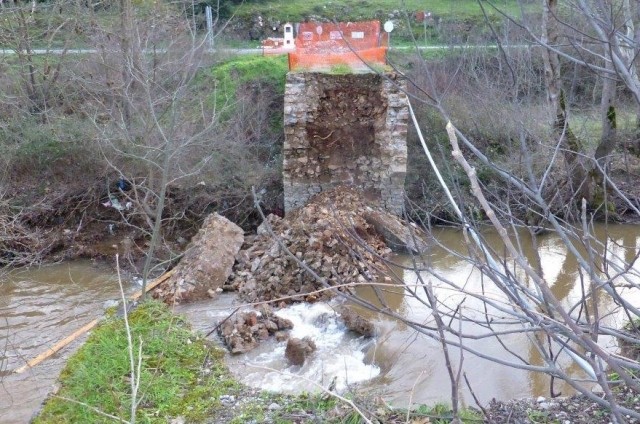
[78,0,226,289]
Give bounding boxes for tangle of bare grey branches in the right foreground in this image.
[370,0,640,422]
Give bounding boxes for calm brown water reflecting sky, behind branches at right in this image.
[358,225,640,404]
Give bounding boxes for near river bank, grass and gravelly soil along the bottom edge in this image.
[23,294,640,424]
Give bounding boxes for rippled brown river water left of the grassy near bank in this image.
[0,261,130,424]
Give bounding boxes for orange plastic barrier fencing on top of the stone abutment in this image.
[289,21,389,71]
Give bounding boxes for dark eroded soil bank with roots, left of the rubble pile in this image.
[0,176,256,272]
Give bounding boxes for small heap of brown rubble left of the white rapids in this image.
[218,309,293,353]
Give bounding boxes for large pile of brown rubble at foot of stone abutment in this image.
[224,186,398,305]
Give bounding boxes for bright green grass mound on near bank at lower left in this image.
[34,301,238,423]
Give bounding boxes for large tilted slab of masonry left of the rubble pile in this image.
[154,213,244,303]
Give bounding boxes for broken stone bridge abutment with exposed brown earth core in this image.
[283,72,409,215]
